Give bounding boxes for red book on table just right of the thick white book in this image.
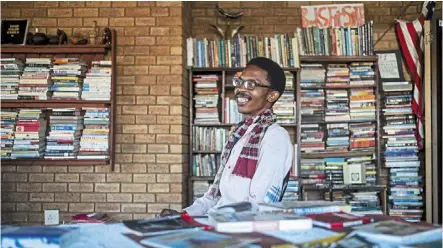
[306,212,374,229]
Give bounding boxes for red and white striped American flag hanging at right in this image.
[395,1,435,149]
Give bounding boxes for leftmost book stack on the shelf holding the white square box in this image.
[300,159,326,185]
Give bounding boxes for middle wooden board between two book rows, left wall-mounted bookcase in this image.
[1,100,112,108]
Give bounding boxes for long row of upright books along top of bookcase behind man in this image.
[186,21,374,68]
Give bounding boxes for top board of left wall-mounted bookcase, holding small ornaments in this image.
[2,45,111,54]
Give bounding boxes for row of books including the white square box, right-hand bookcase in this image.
[299,156,376,186]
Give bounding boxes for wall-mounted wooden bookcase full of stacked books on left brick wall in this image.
[1,30,116,169]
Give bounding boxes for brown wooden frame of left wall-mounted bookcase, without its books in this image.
[1,30,117,169]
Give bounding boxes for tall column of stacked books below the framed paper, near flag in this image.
[382,82,423,222]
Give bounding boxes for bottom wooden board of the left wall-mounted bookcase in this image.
[2,158,110,166]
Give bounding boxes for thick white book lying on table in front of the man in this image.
[209,212,312,233]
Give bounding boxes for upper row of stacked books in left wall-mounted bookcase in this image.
[0,58,112,100]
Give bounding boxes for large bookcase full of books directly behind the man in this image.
[187,25,394,217]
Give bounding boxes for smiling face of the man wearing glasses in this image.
[235,65,278,117]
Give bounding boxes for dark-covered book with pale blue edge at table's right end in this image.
[353,220,442,244]
